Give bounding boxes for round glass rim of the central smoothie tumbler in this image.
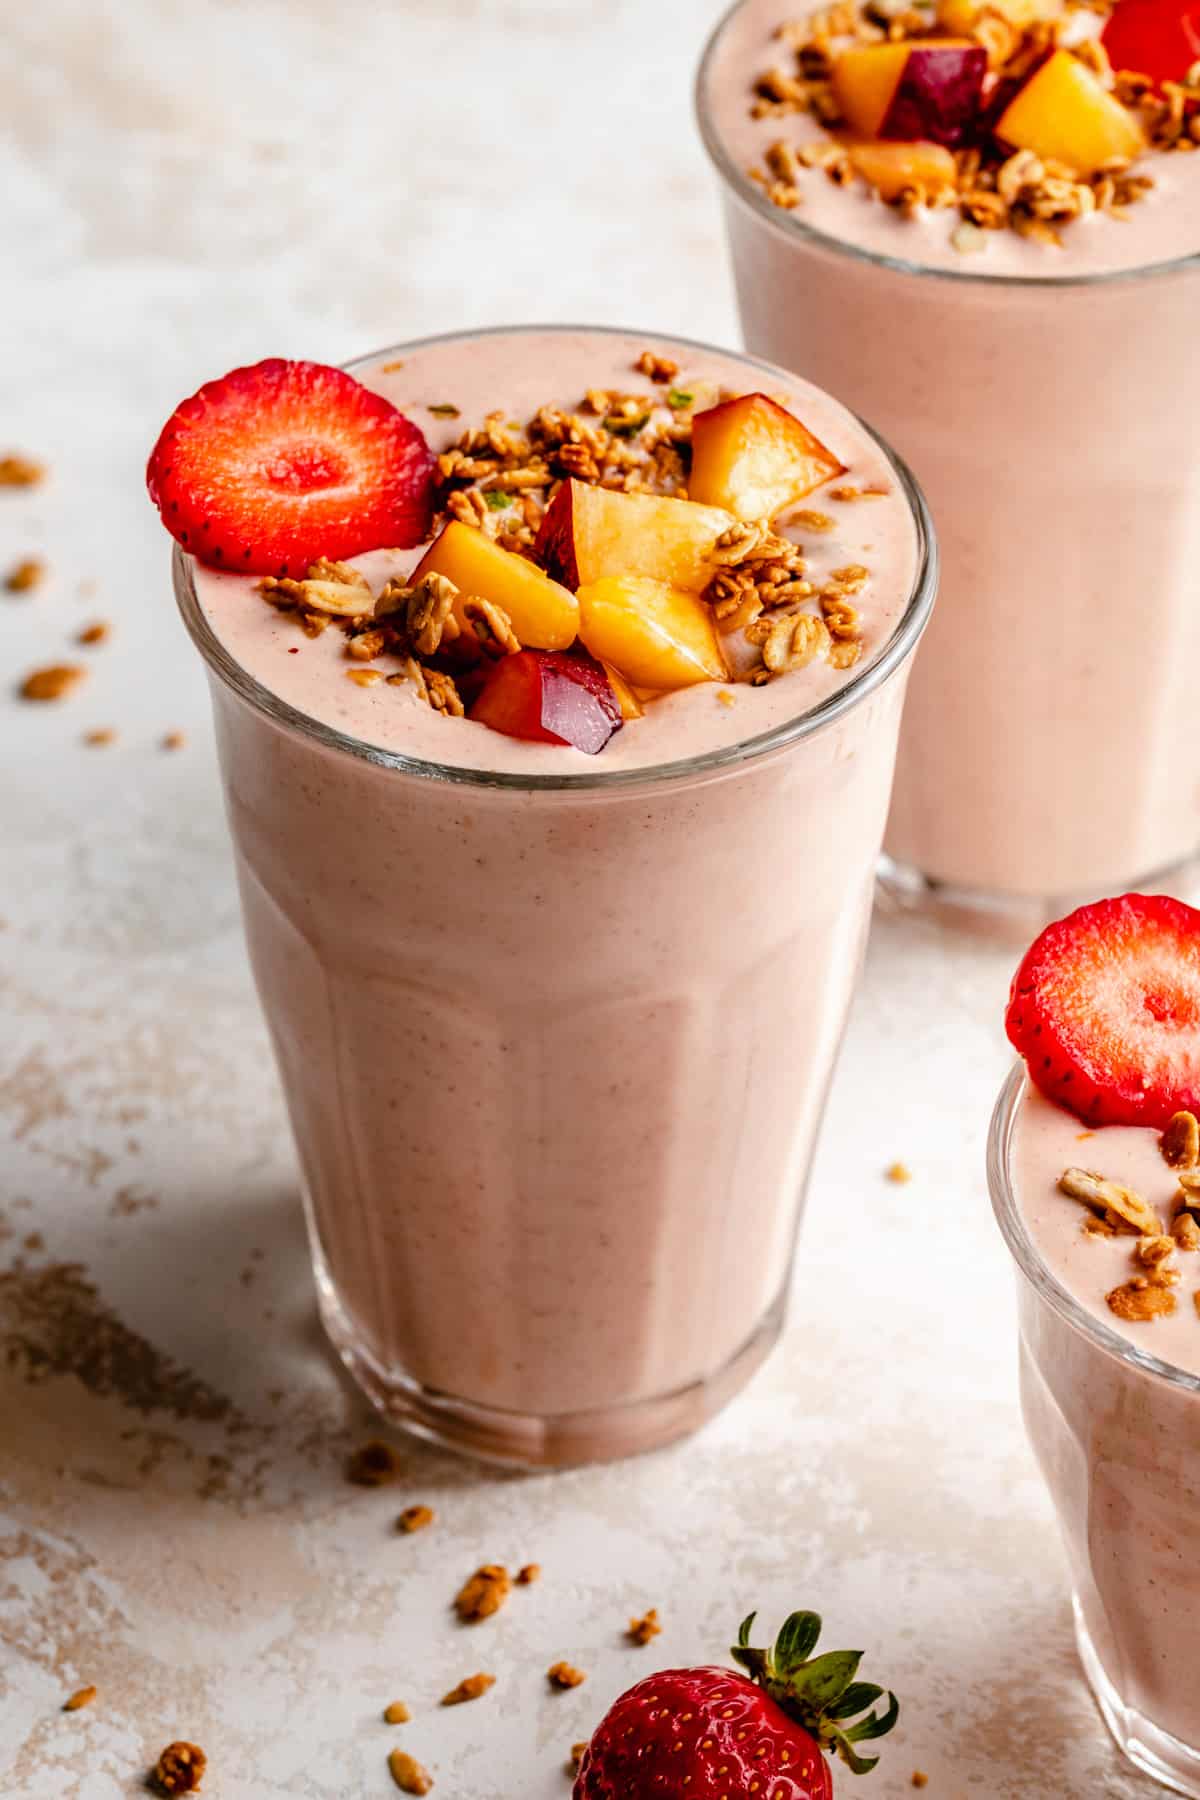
[171,324,937,792]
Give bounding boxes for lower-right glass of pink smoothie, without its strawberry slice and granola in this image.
[988,1066,1200,1795]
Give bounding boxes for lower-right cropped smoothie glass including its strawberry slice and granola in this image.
[990,895,1200,1796]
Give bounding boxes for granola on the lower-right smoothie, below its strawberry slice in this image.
[1058,1112,1200,1323]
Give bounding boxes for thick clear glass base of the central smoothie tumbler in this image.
[315,1265,786,1471]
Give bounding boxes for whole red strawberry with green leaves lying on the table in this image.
[572,1613,900,1800]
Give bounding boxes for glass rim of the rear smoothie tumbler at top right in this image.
[693,0,1200,290]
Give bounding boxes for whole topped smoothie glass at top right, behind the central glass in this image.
[698,0,1200,931]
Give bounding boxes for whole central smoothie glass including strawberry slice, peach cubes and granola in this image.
[151,328,934,1465]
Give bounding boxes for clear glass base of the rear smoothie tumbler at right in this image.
[876,851,1200,947]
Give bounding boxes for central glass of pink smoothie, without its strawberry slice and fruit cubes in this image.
[176,328,932,1465]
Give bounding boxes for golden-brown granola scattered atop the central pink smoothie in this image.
[257,351,874,698]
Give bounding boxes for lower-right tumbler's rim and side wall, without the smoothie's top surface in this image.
[988,1067,1200,1800]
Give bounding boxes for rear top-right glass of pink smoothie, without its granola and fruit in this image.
[698,0,1200,932]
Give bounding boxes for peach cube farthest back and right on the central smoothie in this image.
[687,394,846,520]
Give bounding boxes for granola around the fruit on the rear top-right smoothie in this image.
[748,0,1200,254]
